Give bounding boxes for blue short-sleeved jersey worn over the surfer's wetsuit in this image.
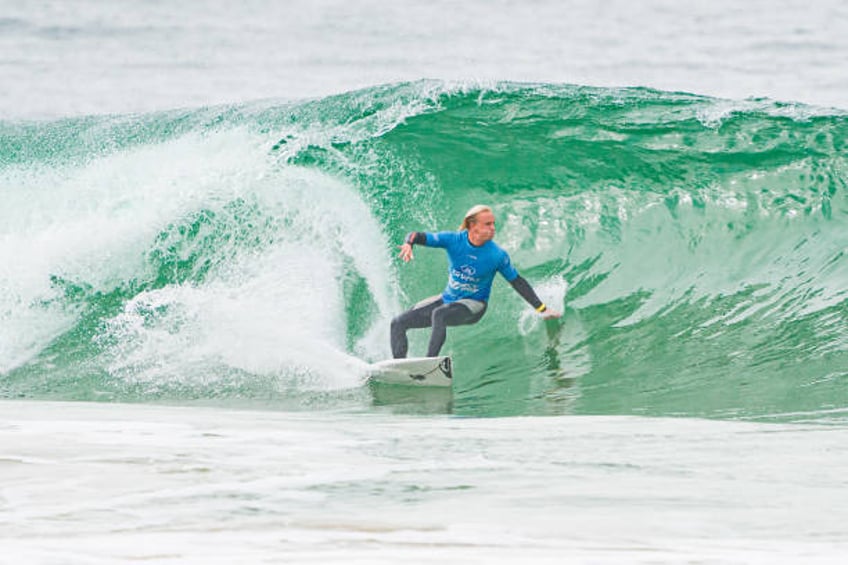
[425,230,518,304]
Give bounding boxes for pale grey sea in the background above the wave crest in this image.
[0,0,848,119]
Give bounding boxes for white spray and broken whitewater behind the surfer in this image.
[0,129,395,387]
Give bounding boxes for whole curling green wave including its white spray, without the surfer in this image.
[0,82,848,421]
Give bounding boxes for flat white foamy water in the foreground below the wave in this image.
[0,401,848,564]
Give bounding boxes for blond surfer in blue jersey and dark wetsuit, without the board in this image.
[391,204,561,359]
